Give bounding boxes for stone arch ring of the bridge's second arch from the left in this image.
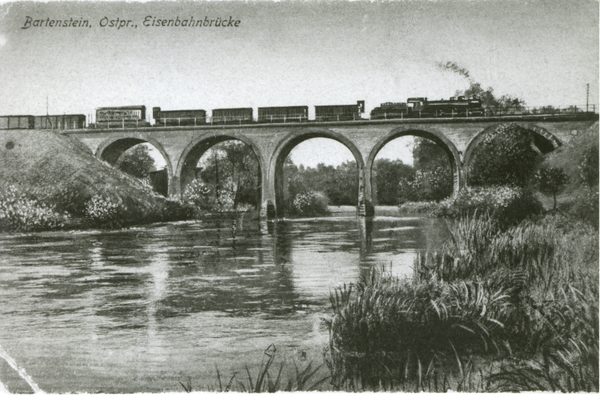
[173,132,265,204]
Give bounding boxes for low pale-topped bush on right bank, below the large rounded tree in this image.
[438,186,543,226]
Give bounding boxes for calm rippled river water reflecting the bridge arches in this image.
[0,212,447,393]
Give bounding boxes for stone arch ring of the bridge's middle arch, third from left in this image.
[263,128,365,218]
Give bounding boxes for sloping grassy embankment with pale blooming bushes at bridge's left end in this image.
[0,130,192,232]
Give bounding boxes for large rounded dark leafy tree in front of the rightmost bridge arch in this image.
[469,124,541,187]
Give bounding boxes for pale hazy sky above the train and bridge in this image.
[0,0,599,167]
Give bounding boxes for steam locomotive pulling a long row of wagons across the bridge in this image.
[0,97,595,129]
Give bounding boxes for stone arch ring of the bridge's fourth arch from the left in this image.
[365,126,462,196]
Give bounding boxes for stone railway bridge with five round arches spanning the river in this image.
[64,113,598,217]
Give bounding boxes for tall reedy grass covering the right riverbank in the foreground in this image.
[327,216,598,391]
